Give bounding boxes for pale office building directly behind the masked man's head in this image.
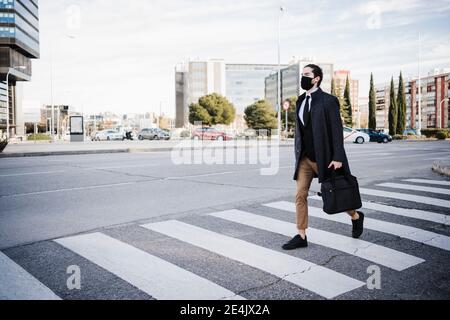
[265,60,334,109]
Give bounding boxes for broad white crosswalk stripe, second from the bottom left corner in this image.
[55,233,243,300]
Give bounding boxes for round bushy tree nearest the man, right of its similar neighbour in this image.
[244,100,278,130]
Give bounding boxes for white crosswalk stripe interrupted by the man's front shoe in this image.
[211,210,425,271]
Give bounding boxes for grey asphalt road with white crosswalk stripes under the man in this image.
[0,141,450,299]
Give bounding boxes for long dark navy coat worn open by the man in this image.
[294,88,351,183]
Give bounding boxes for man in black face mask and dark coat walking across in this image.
[283,64,364,250]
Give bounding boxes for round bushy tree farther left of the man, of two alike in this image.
[189,93,236,126]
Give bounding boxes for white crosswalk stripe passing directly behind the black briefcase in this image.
[309,196,450,225]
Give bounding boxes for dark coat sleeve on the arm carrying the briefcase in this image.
[327,97,345,162]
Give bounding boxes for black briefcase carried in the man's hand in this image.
[321,170,362,214]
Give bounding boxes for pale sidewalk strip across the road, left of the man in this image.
[0,140,294,158]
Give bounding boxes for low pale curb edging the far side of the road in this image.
[0,144,294,159]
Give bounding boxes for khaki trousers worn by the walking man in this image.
[295,156,356,231]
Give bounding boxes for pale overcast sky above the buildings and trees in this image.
[24,0,450,116]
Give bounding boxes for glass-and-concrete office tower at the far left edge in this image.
[0,0,39,136]
